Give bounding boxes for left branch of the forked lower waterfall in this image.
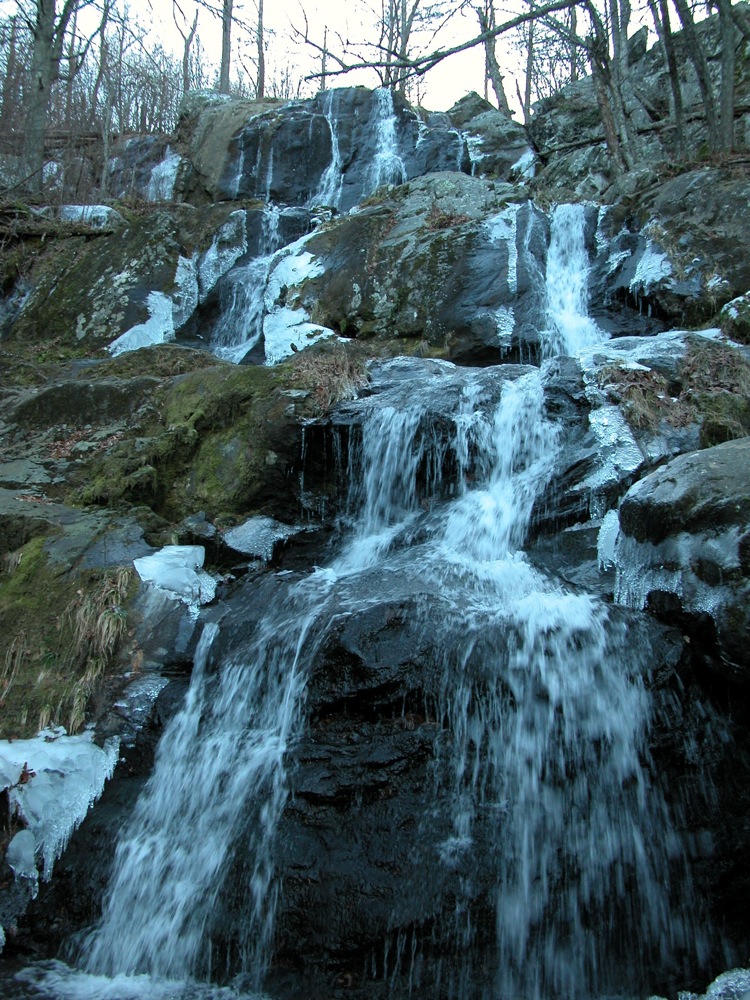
[81,574,330,986]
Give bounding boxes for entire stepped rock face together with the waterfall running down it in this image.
[0,47,750,1000]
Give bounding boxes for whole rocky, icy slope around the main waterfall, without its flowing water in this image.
[0,25,750,997]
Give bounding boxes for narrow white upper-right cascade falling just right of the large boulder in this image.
[541,205,605,357]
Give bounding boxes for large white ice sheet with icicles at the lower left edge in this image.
[0,729,119,879]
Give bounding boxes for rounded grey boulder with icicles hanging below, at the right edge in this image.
[617,438,750,683]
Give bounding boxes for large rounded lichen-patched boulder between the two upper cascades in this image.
[276,173,548,363]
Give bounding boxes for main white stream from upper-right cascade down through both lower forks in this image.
[10,203,716,1000]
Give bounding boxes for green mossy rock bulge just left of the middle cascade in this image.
[78,352,314,520]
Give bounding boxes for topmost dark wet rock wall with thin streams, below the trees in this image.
[180,87,470,211]
